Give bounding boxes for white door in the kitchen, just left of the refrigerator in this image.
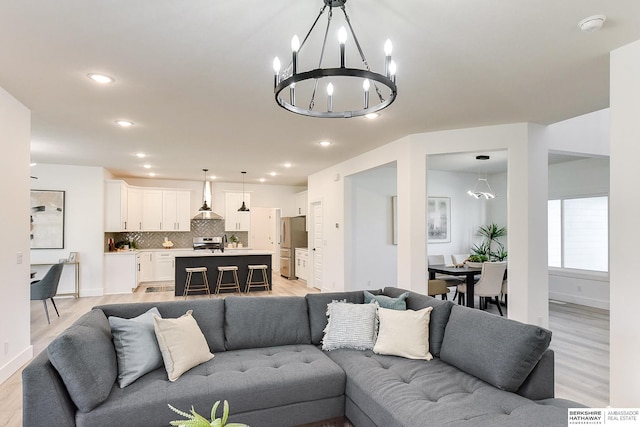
[249,207,280,271]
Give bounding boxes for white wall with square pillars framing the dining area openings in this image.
[309,124,548,326]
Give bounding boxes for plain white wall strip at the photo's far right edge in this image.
[609,37,640,408]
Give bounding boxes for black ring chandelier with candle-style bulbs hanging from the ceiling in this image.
[273,0,397,118]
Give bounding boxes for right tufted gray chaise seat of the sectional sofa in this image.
[327,350,567,427]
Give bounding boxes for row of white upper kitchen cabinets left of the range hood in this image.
[105,180,191,232]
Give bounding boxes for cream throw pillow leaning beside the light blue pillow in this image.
[154,310,213,381]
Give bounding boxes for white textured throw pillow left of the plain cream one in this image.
[322,301,377,351]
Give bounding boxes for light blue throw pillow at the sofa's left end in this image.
[109,307,163,388]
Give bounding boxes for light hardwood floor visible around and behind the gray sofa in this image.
[0,280,609,427]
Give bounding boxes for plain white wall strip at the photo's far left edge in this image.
[0,88,33,383]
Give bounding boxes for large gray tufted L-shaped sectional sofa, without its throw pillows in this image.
[23,288,580,427]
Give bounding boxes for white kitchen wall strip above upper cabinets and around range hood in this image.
[125,175,306,216]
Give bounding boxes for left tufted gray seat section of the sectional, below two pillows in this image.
[76,345,345,427]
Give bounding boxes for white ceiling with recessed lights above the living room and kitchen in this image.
[0,0,640,185]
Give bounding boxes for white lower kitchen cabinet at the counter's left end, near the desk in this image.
[104,251,138,295]
